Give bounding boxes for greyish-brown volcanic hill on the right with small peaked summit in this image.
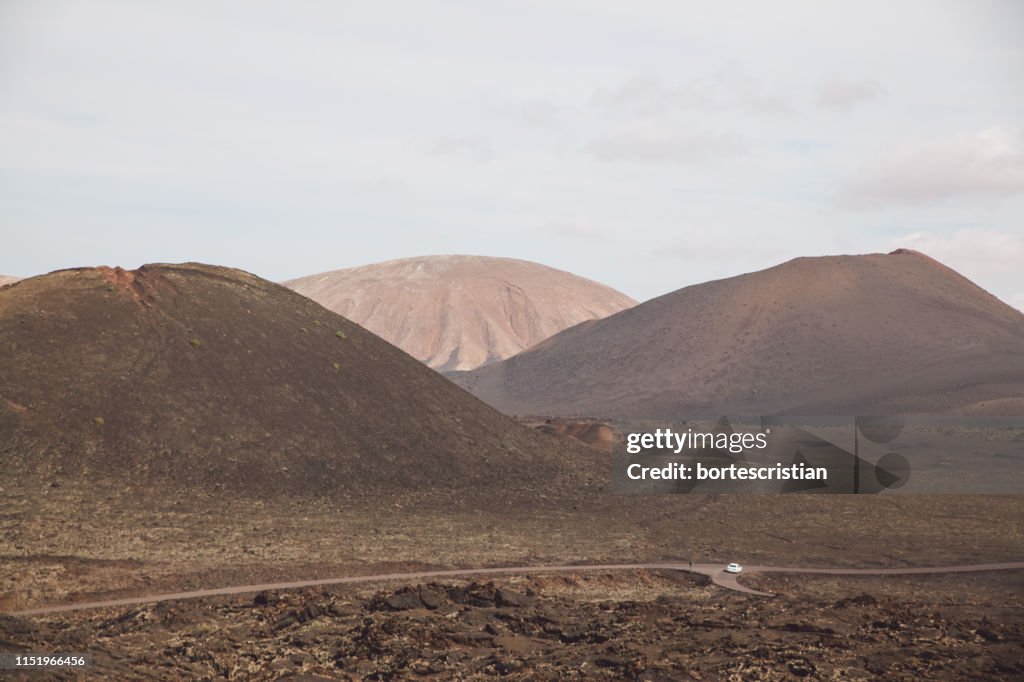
[457,250,1024,417]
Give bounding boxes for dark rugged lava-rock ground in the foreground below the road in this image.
[0,571,1024,680]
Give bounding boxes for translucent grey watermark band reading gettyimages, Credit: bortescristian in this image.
[612,416,1024,495]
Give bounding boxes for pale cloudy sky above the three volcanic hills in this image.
[0,0,1024,309]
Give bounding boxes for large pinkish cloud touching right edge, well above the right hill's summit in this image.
[839,128,1024,208]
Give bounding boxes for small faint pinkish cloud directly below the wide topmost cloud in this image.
[587,123,748,164]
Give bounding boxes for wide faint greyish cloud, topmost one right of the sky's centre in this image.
[591,62,793,117]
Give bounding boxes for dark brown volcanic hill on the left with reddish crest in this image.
[0,263,593,495]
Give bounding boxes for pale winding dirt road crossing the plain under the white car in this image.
[6,561,1024,616]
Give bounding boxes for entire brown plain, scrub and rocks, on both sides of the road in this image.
[0,485,1024,680]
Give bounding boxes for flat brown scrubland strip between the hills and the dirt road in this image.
[0,485,1024,610]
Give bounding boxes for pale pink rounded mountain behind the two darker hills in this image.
[285,256,636,371]
